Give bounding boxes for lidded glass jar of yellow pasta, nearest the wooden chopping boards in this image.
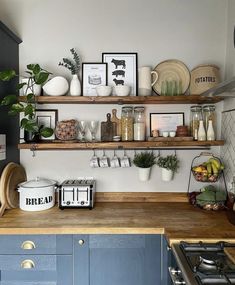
[121,106,134,141]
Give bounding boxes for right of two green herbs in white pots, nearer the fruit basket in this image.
[157,155,179,182]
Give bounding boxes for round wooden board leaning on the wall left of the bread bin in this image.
[0,162,27,209]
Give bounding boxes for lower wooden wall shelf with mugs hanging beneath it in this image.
[18,140,224,150]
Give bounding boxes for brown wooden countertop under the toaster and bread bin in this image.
[0,202,235,243]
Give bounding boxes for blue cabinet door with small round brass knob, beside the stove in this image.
[74,235,162,285]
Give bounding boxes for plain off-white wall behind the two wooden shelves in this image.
[0,0,227,192]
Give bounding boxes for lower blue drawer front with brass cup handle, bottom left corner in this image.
[0,255,73,285]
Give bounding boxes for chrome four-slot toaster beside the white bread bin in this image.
[59,178,96,210]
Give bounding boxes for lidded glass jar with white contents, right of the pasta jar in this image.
[134,106,145,141]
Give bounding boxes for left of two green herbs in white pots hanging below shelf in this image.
[133,151,156,181]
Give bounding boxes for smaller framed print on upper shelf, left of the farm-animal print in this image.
[82,62,107,96]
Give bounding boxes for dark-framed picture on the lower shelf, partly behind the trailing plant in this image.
[36,109,58,140]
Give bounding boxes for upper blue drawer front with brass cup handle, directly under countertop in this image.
[0,235,72,254]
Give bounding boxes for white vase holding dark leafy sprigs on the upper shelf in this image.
[59,48,81,96]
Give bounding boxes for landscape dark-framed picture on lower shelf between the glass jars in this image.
[150,113,184,136]
